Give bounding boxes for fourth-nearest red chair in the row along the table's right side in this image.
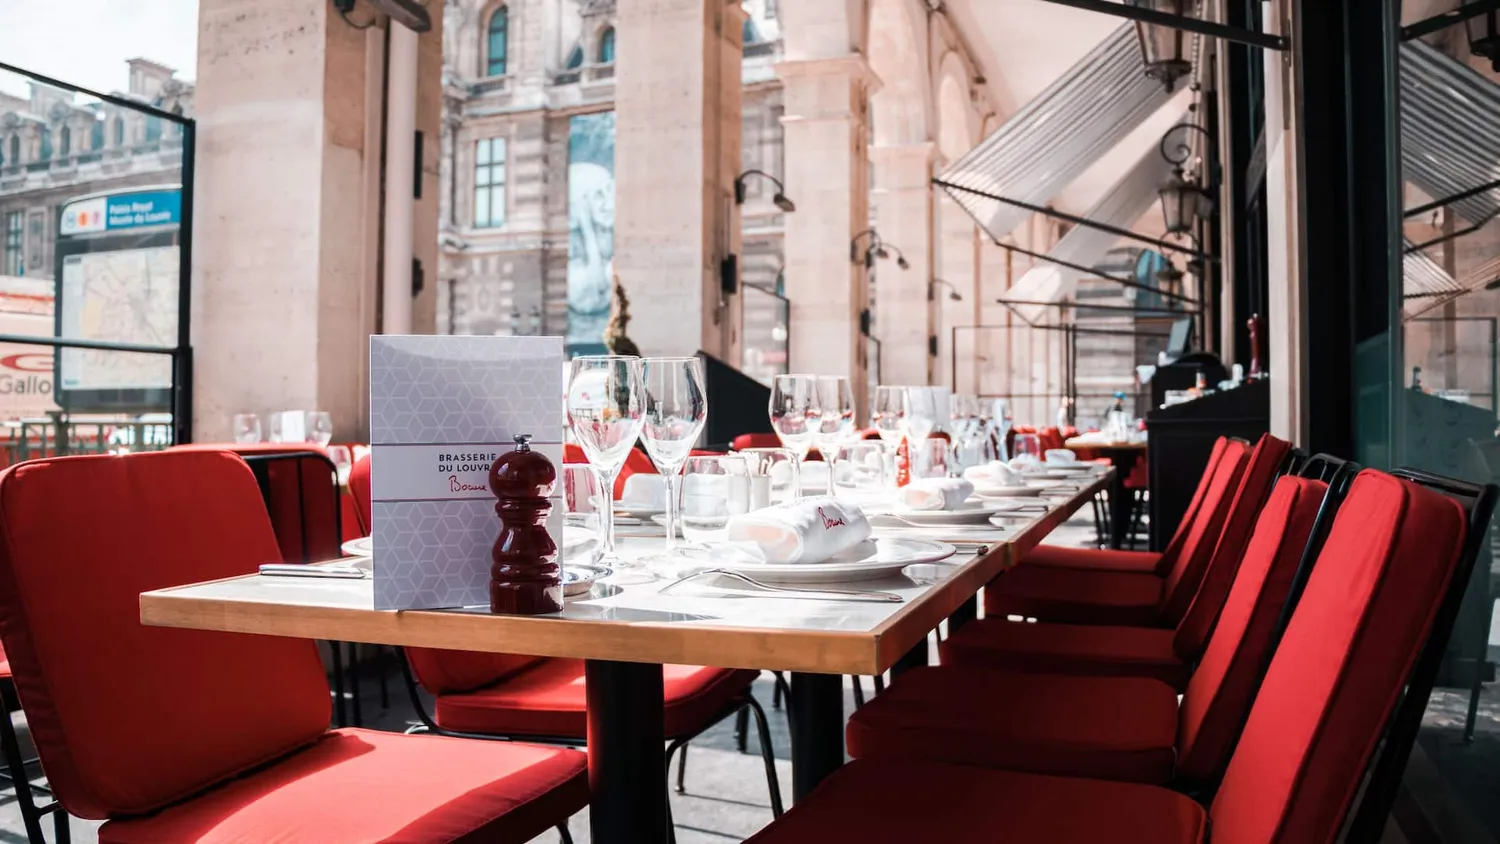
[984,441,1254,627]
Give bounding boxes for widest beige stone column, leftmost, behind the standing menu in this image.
[192,0,443,442]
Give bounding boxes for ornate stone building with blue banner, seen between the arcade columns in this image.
[437,0,786,370]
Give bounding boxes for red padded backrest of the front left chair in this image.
[0,451,329,819]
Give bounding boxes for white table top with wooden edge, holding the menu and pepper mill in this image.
[141,472,1110,675]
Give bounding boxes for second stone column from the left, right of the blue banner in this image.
[615,0,744,359]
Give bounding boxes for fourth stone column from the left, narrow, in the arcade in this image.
[870,142,947,384]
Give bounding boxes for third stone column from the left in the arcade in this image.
[776,54,876,408]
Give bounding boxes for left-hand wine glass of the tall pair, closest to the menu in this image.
[567,355,642,568]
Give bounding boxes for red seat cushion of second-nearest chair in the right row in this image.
[846,667,1178,783]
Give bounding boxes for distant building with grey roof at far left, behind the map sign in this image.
[0,58,194,279]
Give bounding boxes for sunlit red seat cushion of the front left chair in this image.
[99,725,588,844]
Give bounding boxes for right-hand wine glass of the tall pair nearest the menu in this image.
[641,357,708,552]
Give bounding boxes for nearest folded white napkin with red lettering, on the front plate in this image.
[728,495,870,564]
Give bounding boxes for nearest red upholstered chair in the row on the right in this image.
[747,471,1494,844]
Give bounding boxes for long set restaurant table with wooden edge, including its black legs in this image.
[141,472,1112,844]
